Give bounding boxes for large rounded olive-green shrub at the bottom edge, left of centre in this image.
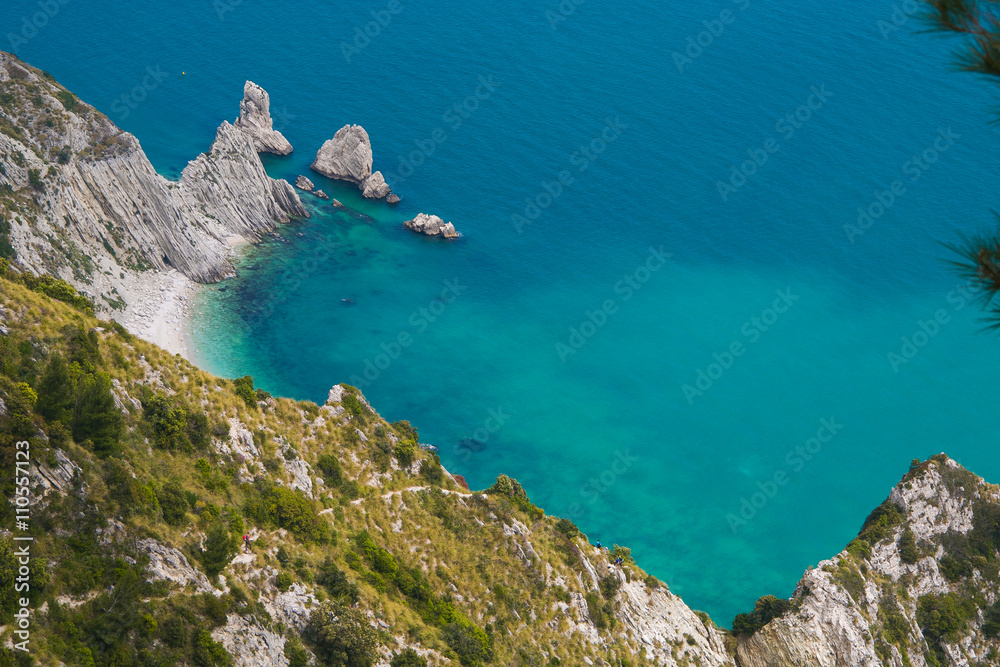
[306,601,378,667]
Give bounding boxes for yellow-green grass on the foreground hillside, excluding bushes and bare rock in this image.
[0,272,672,665]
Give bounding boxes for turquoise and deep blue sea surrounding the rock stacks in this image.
[11,0,1000,625]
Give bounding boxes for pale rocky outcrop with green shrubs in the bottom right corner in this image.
[736,455,1000,667]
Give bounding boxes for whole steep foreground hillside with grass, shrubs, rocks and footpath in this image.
[0,269,733,665]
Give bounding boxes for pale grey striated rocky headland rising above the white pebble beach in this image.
[0,52,306,311]
